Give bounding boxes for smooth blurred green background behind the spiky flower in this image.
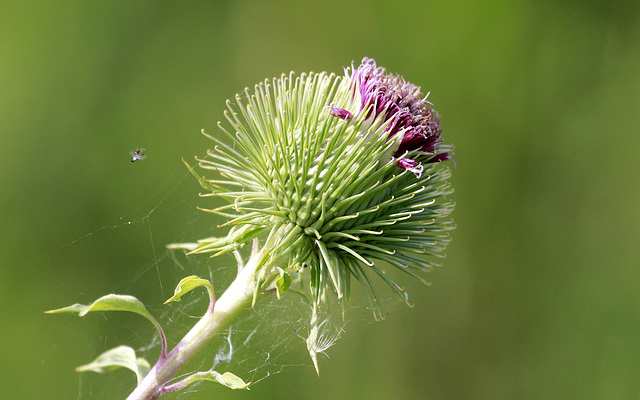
[0,0,640,400]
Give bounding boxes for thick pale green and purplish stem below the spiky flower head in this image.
[127,251,264,400]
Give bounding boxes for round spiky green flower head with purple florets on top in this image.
[179,58,453,318]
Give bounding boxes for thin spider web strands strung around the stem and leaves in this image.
[28,134,400,400]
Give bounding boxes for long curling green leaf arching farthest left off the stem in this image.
[45,294,167,355]
